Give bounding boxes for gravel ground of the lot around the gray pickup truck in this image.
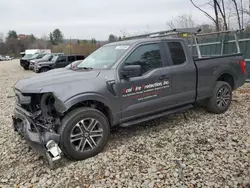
[0,60,250,188]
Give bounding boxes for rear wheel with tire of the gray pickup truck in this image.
[207,81,232,114]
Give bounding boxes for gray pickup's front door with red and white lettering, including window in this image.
[118,42,170,121]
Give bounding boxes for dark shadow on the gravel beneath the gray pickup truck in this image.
[40,103,208,170]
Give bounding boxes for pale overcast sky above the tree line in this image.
[0,0,213,40]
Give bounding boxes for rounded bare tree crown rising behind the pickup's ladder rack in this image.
[167,14,196,29]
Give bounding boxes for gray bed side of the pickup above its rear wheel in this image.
[193,53,246,100]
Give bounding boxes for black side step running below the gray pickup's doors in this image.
[120,104,193,127]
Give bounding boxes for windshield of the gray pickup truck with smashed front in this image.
[77,45,129,69]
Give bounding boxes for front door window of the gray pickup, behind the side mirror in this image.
[125,44,162,73]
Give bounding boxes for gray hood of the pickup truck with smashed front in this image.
[15,68,100,93]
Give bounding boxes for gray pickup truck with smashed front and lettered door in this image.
[13,27,246,167]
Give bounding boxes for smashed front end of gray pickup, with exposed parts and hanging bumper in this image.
[12,90,62,168]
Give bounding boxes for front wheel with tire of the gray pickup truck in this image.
[58,107,110,160]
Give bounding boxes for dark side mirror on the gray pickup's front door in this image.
[121,65,142,78]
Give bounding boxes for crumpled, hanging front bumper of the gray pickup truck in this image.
[12,105,61,167]
